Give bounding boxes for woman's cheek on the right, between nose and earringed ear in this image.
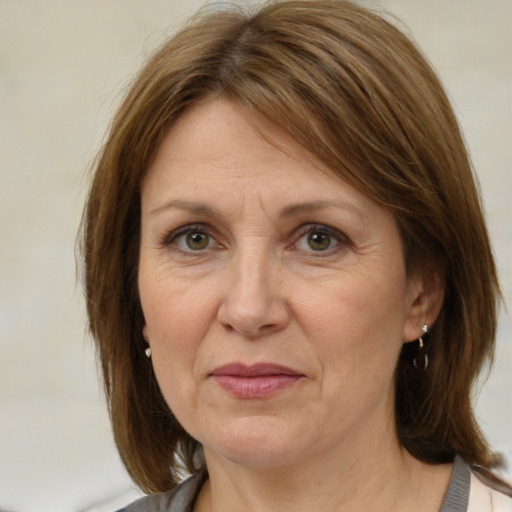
[297,274,405,384]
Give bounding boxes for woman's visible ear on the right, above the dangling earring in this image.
[402,268,446,343]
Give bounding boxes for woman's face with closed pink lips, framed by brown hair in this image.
[139,99,422,467]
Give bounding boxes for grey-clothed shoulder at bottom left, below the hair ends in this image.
[118,475,204,512]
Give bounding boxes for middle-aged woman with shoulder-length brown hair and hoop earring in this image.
[83,1,512,512]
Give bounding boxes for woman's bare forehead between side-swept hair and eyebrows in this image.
[142,98,368,211]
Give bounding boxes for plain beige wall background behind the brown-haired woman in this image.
[0,0,512,512]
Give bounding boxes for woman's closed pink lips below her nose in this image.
[210,363,304,398]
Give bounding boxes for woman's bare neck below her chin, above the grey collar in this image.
[195,414,451,512]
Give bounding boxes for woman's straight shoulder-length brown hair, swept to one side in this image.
[82,0,499,492]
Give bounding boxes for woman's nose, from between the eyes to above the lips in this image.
[217,245,290,339]
